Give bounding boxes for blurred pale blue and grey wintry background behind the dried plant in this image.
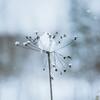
[0,0,100,100]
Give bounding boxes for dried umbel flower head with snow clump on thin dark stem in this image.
[15,32,77,100]
